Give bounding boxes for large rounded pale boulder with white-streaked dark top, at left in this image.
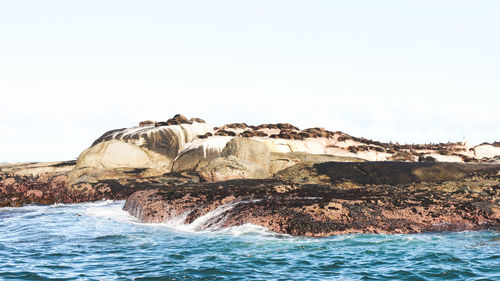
[71,115,212,182]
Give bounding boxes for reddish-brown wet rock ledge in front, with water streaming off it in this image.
[124,174,500,237]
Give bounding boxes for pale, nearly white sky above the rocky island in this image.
[0,0,500,162]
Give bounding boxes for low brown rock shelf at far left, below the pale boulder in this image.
[0,161,199,207]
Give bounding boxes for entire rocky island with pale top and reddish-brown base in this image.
[0,114,500,236]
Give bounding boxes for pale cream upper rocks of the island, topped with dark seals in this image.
[70,114,500,183]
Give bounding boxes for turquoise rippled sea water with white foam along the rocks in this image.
[0,201,500,280]
